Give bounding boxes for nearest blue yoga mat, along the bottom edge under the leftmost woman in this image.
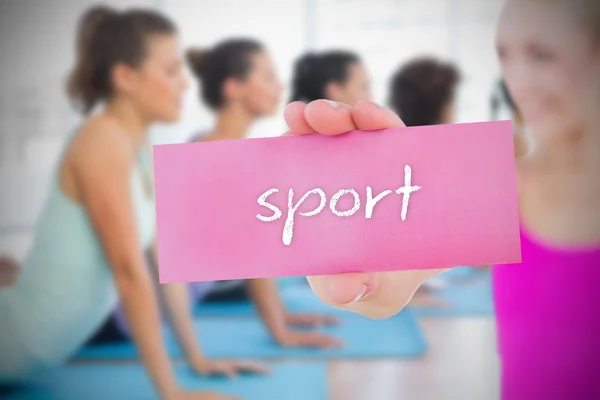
[2,362,328,400]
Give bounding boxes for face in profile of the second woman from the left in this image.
[235,51,283,117]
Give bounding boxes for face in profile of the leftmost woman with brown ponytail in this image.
[116,35,188,122]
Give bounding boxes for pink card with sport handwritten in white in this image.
[154,121,521,283]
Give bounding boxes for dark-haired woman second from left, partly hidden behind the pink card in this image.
[178,39,340,347]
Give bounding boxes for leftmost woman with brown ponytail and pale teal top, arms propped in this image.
[0,7,255,400]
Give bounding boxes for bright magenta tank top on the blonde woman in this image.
[493,230,600,400]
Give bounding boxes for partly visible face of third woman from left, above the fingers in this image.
[325,62,373,106]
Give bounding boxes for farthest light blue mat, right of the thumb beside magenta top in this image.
[411,272,494,317]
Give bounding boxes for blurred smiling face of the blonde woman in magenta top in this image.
[497,0,600,141]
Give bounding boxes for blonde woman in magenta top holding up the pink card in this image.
[285,0,600,400]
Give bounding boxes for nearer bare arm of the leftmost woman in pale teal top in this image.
[73,132,178,398]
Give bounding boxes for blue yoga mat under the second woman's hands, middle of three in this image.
[77,310,426,360]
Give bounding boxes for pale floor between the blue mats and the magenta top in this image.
[329,318,499,400]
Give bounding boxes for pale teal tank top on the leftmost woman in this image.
[0,143,155,379]
